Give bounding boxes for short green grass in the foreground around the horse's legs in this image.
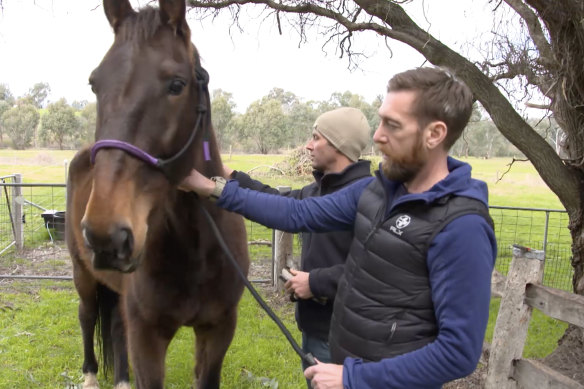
[0,281,304,389]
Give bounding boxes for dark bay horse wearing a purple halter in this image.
[66,0,249,389]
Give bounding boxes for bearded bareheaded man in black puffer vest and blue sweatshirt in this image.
[180,67,497,389]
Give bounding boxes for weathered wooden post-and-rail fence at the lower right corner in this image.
[485,246,584,389]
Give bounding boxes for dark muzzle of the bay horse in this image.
[82,226,138,273]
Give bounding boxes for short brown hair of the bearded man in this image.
[387,67,474,150]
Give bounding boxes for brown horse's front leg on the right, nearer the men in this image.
[195,306,237,389]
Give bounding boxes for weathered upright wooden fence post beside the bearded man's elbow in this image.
[485,245,545,389]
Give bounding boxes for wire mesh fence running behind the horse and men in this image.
[0,180,573,291]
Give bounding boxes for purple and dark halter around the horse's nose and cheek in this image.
[90,66,211,174]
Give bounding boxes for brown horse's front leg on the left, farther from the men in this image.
[126,302,178,389]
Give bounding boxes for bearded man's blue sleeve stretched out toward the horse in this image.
[216,179,370,232]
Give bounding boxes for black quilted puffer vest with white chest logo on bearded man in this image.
[329,179,492,363]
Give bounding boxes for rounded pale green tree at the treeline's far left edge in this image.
[2,100,40,150]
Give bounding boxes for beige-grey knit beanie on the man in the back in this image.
[314,107,371,162]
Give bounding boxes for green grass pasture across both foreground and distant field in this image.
[0,150,572,388]
